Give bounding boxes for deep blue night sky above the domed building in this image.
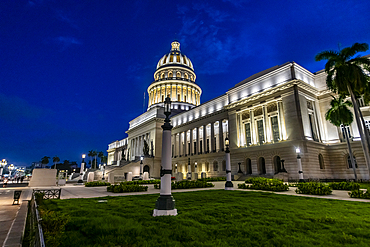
[0,0,370,166]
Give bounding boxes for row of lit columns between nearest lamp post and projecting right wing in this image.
[172,119,229,158]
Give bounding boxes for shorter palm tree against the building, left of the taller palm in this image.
[325,95,357,181]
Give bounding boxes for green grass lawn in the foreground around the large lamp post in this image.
[40,190,370,246]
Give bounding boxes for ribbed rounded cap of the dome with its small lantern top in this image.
[157,41,194,70]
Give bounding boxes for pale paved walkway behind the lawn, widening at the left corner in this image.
[0,181,370,246]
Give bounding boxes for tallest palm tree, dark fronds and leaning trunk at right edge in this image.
[315,43,370,172]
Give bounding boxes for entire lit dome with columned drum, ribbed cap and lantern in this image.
[148,41,202,110]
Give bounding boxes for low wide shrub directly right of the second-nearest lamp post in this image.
[238,177,289,192]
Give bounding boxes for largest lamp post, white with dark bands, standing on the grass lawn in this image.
[153,96,177,216]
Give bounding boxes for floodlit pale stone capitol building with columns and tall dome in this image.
[106,41,370,182]
